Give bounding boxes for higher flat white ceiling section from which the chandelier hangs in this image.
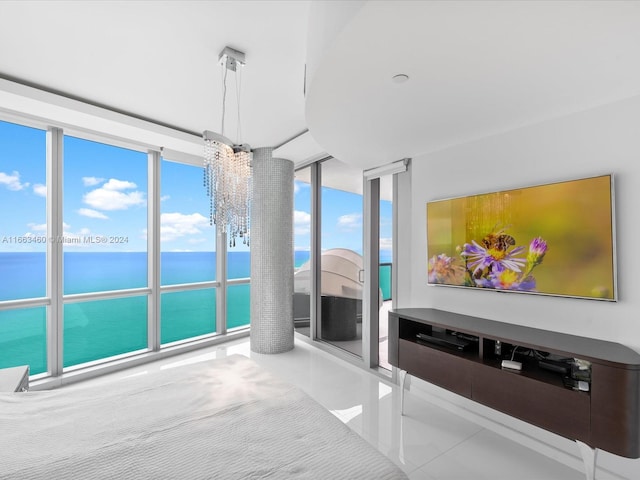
[0,0,309,147]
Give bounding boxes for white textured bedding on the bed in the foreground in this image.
[0,355,407,480]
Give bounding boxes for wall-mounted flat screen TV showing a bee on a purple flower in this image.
[427,175,617,301]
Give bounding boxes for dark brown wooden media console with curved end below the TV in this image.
[389,308,640,458]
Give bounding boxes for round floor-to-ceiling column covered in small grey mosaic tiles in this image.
[251,148,293,353]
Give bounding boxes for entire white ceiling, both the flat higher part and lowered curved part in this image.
[0,0,640,168]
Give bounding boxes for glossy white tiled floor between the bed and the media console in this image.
[64,339,585,480]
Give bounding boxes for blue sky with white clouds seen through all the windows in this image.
[0,121,391,253]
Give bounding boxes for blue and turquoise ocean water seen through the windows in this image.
[0,251,390,374]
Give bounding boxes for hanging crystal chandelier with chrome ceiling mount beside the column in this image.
[202,47,253,247]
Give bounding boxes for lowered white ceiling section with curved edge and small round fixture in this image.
[306,1,640,167]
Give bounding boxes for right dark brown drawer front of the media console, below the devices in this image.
[472,364,591,444]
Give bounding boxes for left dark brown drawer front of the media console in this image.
[398,339,473,398]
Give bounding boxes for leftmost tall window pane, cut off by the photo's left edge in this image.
[0,121,48,374]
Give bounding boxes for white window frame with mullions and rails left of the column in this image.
[0,111,251,389]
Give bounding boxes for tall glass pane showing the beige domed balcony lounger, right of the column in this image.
[316,158,364,356]
